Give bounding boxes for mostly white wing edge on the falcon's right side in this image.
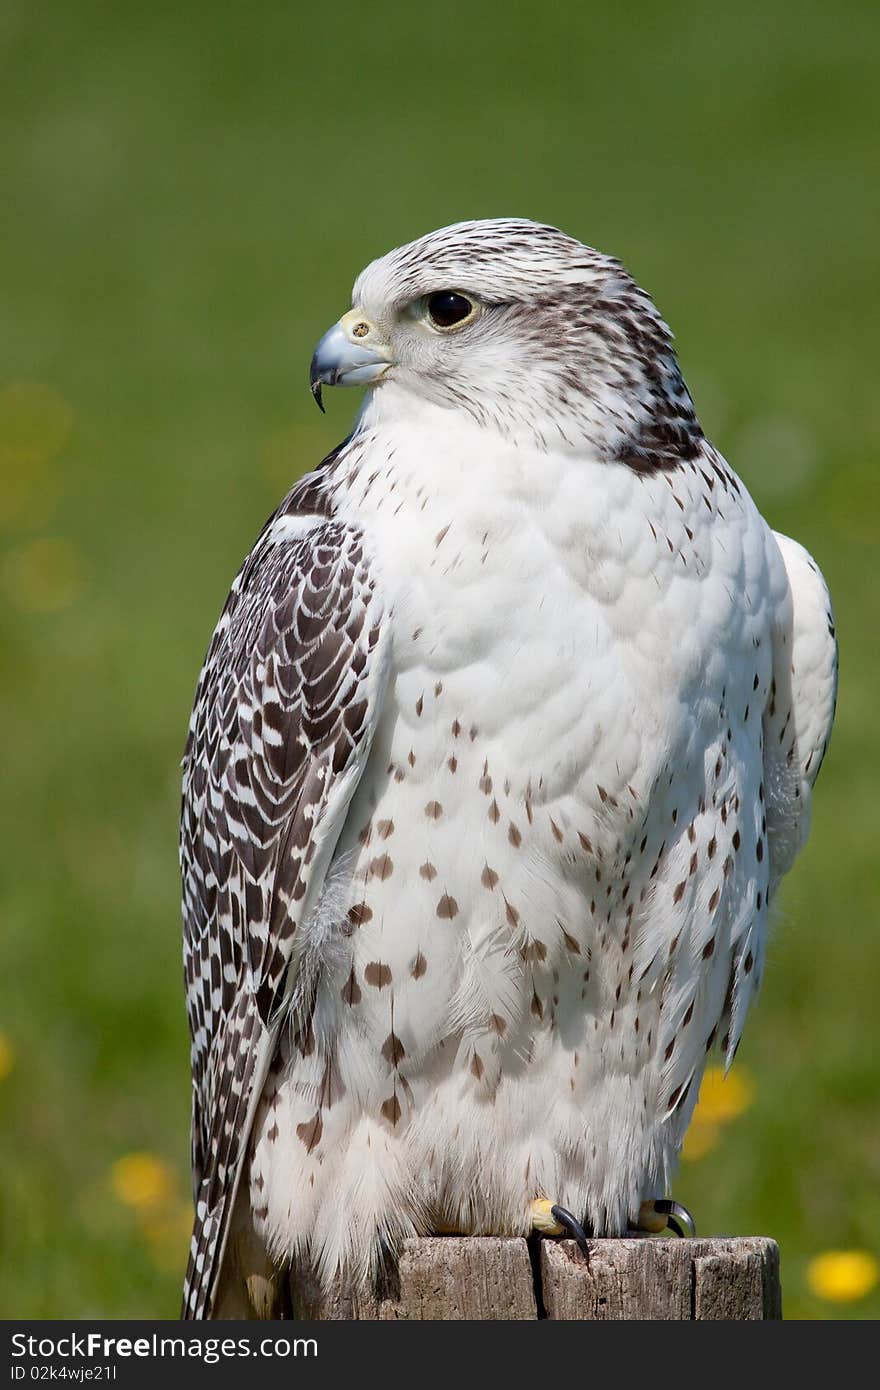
[763,532,837,894]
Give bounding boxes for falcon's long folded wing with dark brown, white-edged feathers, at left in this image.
[181,461,389,1318]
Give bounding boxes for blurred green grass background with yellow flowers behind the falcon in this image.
[0,0,880,1318]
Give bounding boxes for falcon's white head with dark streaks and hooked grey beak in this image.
[311,218,699,467]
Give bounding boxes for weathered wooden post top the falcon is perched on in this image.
[291,1236,783,1322]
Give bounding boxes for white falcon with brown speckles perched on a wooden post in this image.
[181,218,837,1318]
